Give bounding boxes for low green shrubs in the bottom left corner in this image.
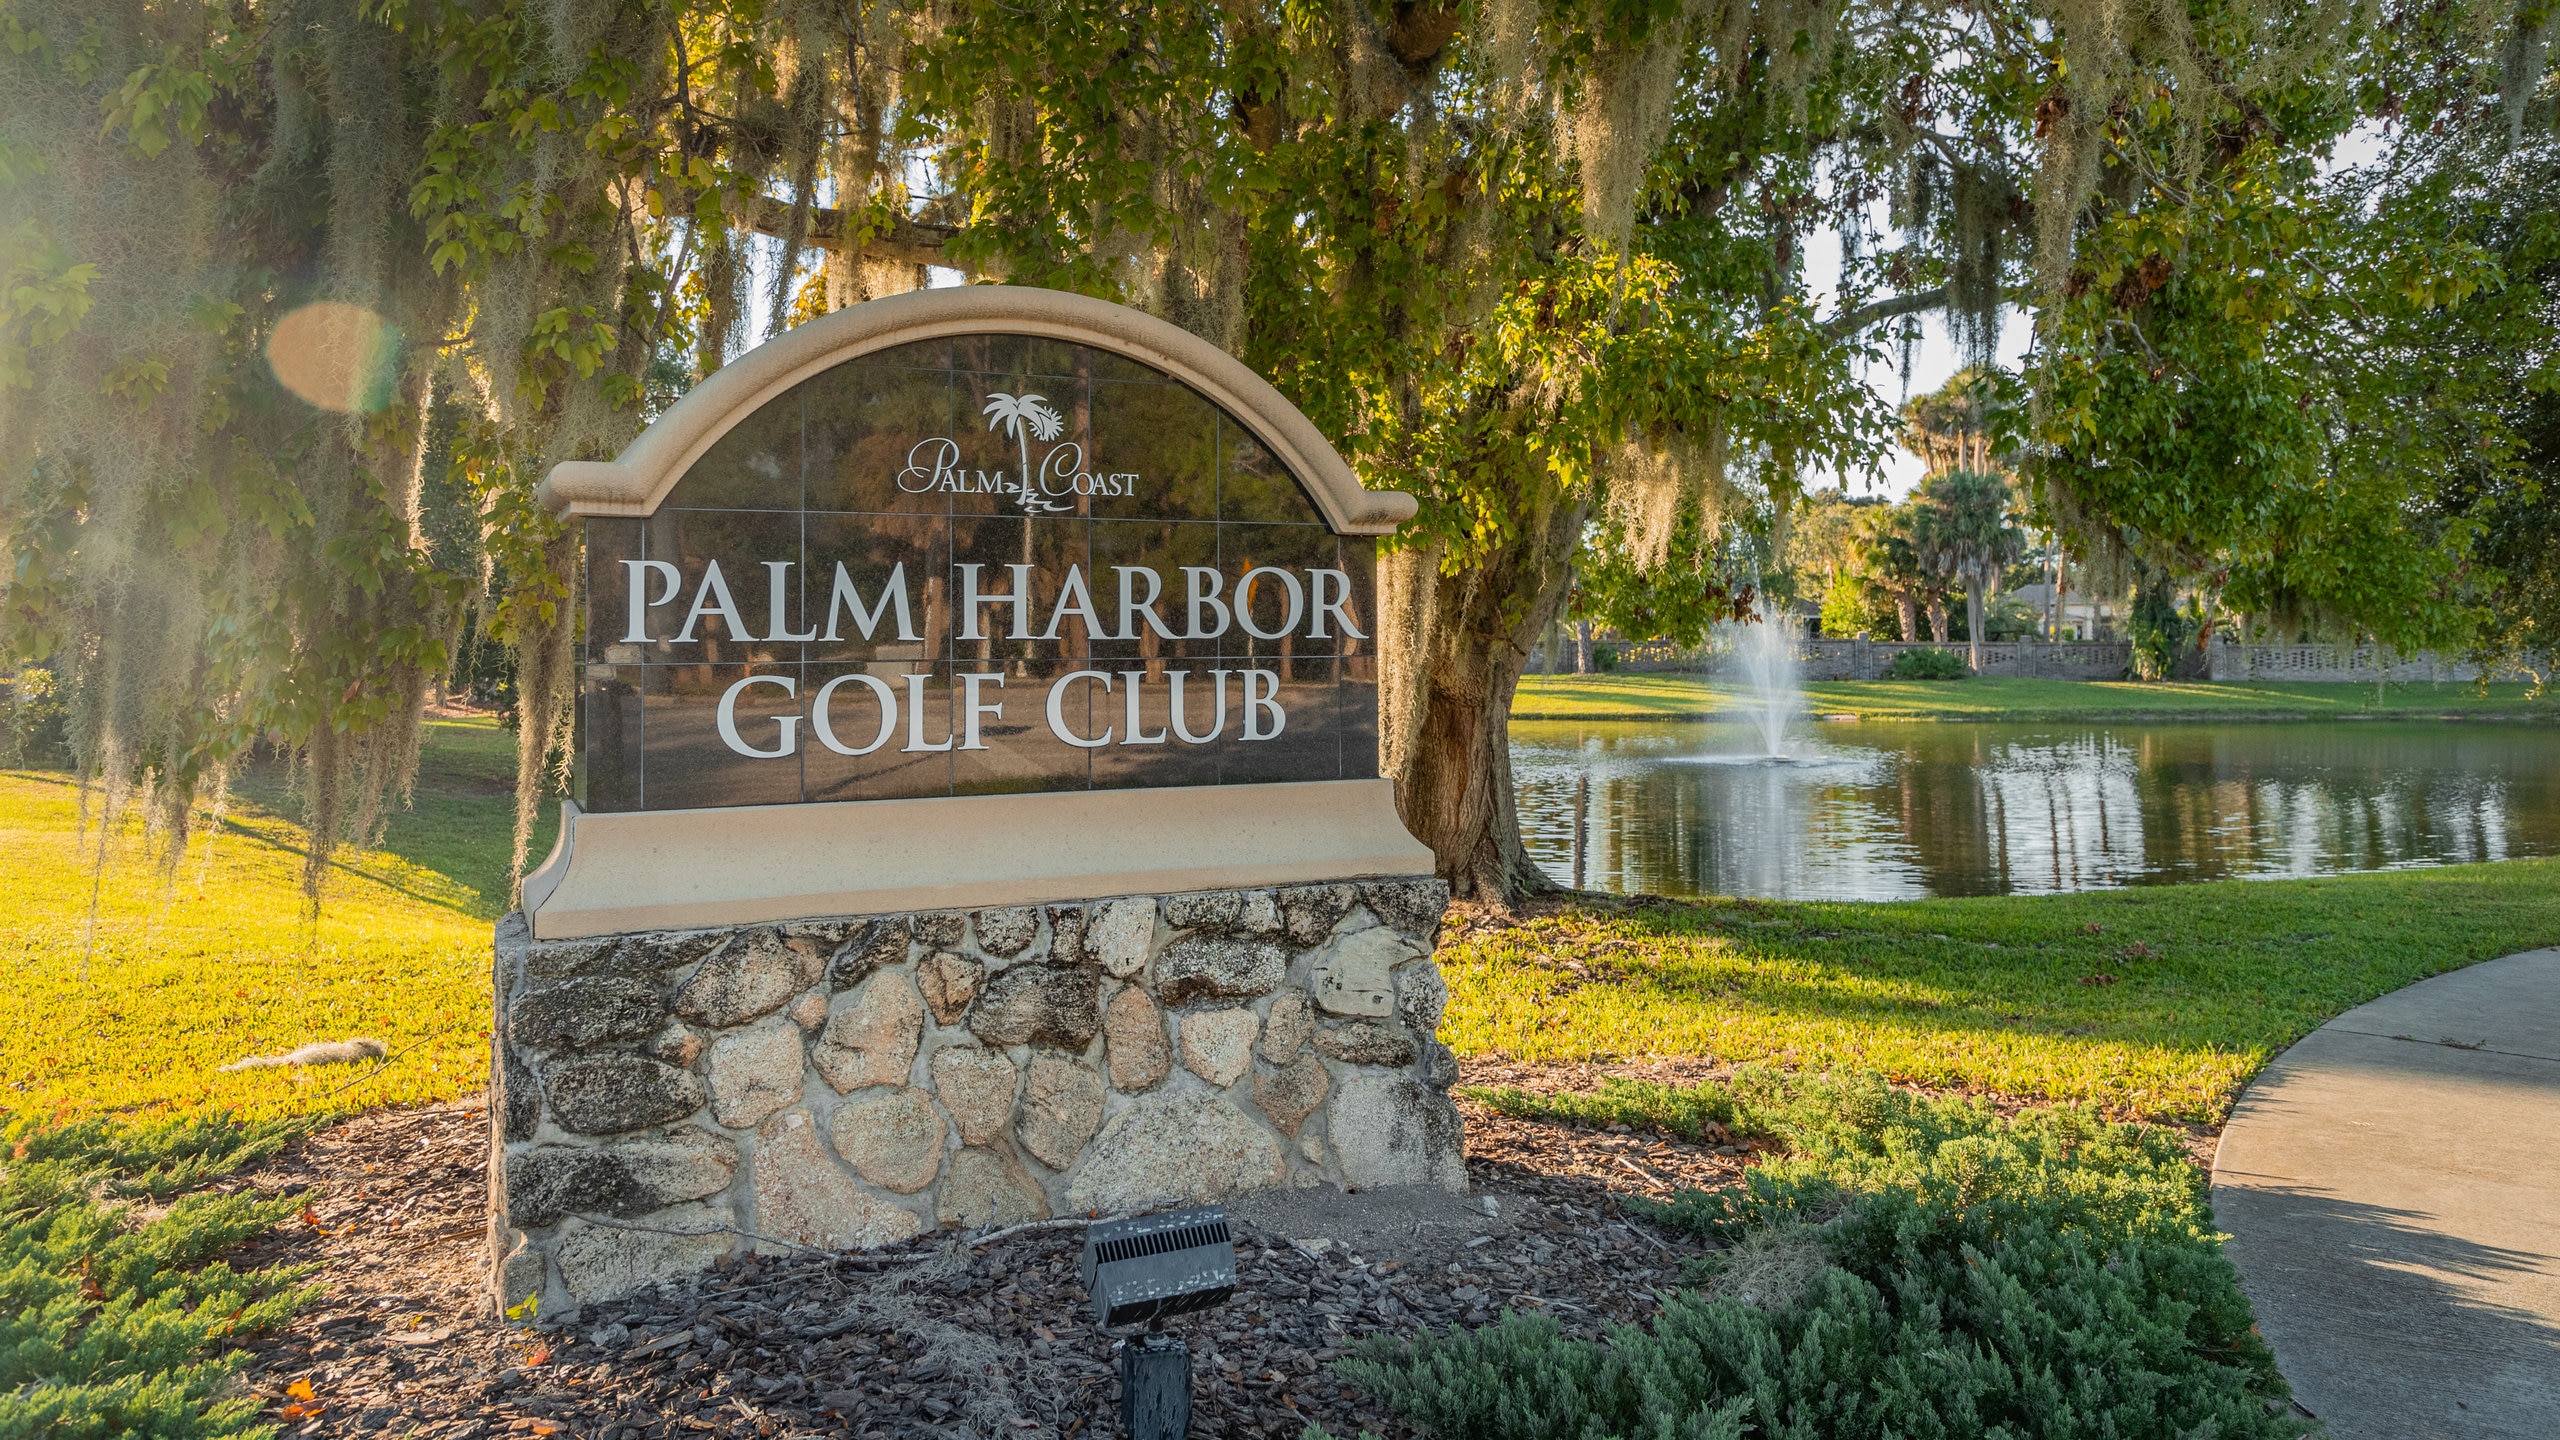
[0,1117,310,1440]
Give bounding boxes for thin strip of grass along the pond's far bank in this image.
[1510,671,2560,720]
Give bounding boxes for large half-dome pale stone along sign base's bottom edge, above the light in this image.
[1068,1092,1288,1212]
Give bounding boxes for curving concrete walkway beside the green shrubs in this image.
[2214,951,2560,1440]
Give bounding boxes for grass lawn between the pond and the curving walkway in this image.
[1439,861,2560,1122]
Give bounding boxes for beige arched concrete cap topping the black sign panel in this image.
[538,284,1418,536]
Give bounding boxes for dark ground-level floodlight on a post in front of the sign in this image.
[1083,1204,1236,1440]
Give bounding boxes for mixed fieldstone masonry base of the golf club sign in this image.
[489,876,1467,1320]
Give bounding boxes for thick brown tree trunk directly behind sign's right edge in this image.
[1377,502,1590,904]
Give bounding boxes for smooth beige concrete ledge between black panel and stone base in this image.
[525,779,1434,940]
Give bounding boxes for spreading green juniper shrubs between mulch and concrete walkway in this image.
[1341,1071,2307,1440]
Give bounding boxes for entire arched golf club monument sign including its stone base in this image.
[489,287,1464,1320]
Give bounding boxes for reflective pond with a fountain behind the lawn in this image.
[1510,723,2560,899]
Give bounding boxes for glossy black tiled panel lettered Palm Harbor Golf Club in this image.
[579,336,1377,812]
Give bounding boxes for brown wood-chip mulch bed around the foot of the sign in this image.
[236,1071,1748,1440]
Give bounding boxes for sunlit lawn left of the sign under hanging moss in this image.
[0,720,550,1120]
